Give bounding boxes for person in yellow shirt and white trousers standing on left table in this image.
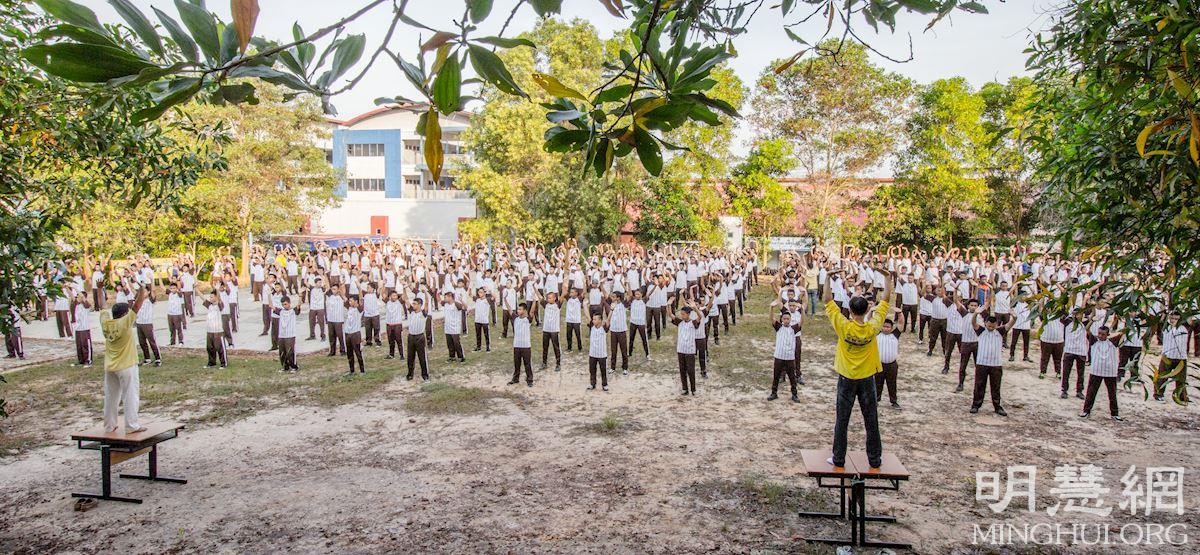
[100,285,150,434]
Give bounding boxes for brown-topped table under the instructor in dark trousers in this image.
[799,449,912,549]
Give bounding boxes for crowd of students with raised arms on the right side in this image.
[781,246,1200,420]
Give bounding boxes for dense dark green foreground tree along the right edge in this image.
[1027,0,1200,402]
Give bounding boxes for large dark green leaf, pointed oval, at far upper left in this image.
[20,42,156,83]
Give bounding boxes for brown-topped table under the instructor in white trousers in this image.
[71,423,187,503]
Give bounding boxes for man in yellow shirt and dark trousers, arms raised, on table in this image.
[822,263,895,469]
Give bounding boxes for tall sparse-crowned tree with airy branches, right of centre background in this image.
[750,41,912,241]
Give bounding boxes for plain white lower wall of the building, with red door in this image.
[313,199,475,241]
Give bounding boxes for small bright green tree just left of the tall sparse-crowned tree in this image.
[728,139,796,239]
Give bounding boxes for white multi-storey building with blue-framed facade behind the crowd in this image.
[307,103,475,241]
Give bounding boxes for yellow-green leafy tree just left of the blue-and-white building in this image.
[186,86,337,274]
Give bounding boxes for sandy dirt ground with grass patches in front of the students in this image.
[0,287,1200,554]
